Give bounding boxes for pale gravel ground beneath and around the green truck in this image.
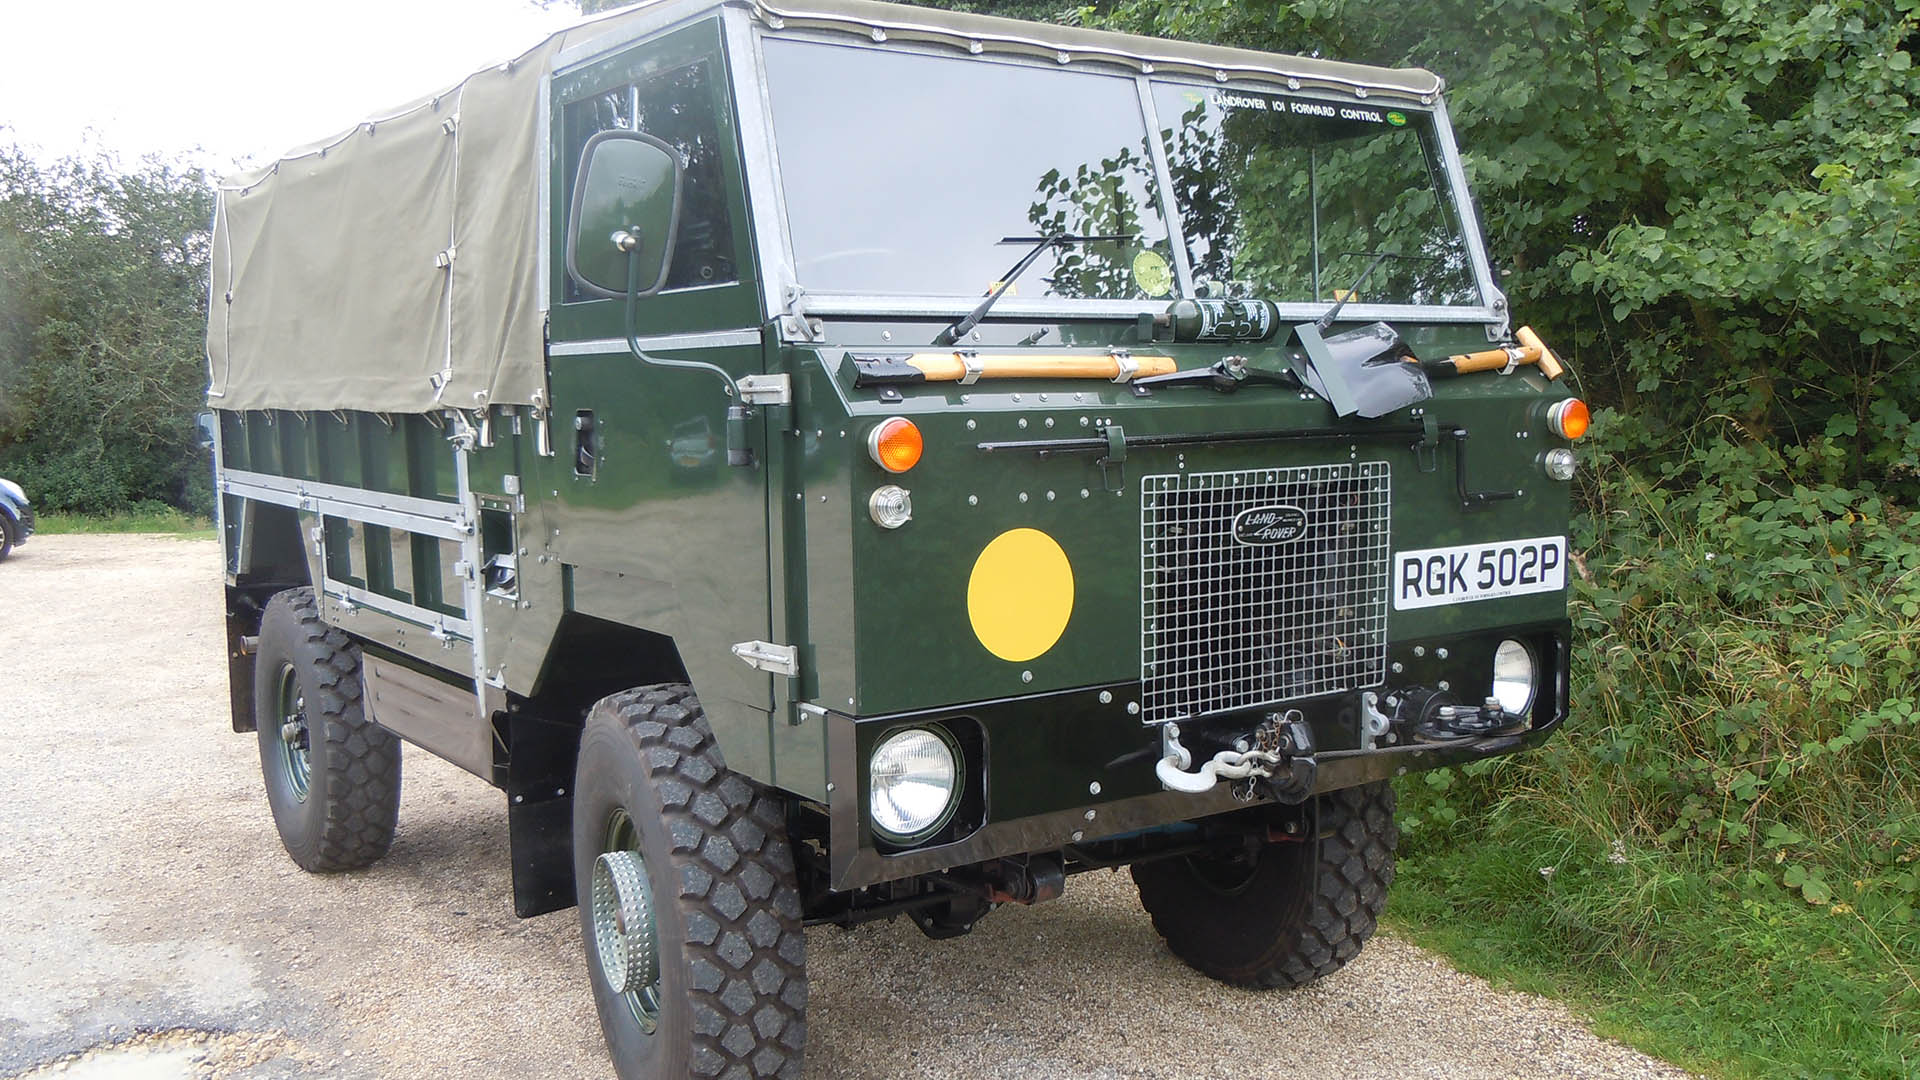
[0,536,1682,1080]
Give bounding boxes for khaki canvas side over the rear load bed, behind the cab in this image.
[207,38,559,413]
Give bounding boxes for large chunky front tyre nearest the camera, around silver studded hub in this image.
[574,684,806,1080]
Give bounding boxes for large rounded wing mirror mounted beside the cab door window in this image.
[566,131,684,298]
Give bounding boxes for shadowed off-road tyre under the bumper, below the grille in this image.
[1133,782,1400,990]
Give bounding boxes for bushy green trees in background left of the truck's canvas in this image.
[0,146,213,513]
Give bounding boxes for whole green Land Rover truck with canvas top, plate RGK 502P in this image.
[207,0,1586,1078]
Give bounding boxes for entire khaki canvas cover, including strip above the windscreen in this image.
[207,0,1440,413]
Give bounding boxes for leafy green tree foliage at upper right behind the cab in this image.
[1104,0,1920,488]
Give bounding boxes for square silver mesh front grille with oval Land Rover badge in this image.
[1140,461,1392,723]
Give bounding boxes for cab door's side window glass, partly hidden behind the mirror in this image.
[564,60,739,302]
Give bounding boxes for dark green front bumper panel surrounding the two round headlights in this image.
[828,621,1571,890]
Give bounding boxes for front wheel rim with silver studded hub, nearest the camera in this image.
[593,809,660,1034]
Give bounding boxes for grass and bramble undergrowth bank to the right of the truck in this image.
[1396,424,1920,1076]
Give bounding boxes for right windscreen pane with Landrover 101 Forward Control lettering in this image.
[1154,83,1480,306]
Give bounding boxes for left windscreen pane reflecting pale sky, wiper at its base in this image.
[764,38,1175,300]
